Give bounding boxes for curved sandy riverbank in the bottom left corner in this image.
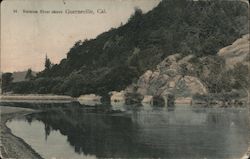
[0,106,42,159]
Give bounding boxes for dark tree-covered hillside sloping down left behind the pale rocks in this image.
[5,0,249,96]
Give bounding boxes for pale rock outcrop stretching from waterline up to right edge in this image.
[122,34,250,105]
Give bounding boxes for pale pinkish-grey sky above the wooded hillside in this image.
[0,0,160,72]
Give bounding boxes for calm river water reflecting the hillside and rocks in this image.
[7,105,250,159]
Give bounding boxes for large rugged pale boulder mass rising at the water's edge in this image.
[137,54,207,97]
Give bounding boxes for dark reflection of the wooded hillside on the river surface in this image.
[26,110,166,157]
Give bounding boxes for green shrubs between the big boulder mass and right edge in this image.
[192,56,250,93]
